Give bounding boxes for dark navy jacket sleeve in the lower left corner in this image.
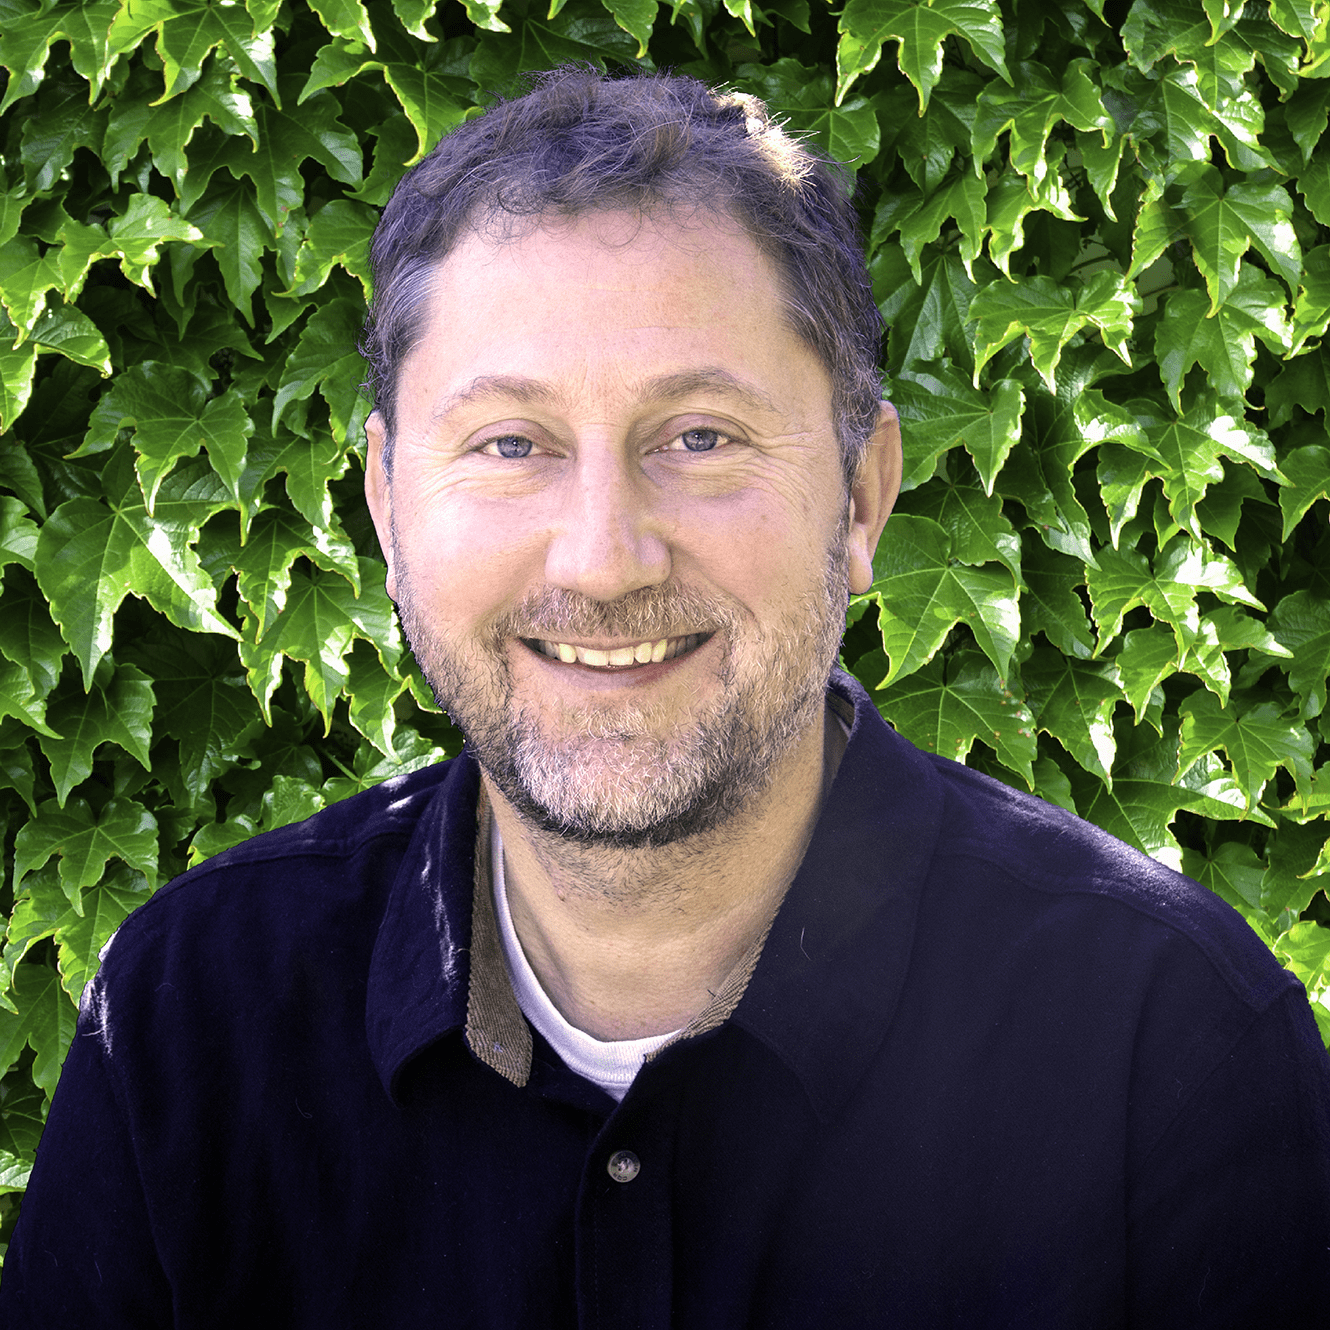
[0,1008,173,1330]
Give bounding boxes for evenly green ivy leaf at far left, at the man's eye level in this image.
[80,360,254,516]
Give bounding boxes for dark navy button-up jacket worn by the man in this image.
[0,676,1330,1330]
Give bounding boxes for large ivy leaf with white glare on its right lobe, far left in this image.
[36,454,237,688]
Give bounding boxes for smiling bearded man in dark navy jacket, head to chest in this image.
[0,69,1330,1330]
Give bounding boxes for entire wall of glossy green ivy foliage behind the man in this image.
[0,0,1330,1255]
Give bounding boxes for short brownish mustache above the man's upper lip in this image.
[493,583,742,644]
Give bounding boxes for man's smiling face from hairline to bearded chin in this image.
[368,213,893,846]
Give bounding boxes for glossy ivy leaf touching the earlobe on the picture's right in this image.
[871,513,1020,684]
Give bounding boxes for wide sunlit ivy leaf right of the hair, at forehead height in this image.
[970,270,1141,392]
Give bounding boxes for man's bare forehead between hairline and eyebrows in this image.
[400,213,830,417]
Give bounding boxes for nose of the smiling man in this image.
[545,446,670,601]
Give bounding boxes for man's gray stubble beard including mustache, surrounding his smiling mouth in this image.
[394,525,847,850]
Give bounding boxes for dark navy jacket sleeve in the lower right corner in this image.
[1127,987,1330,1330]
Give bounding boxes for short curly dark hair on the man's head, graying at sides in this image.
[360,65,882,487]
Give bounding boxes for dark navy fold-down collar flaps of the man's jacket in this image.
[366,670,942,1116]
